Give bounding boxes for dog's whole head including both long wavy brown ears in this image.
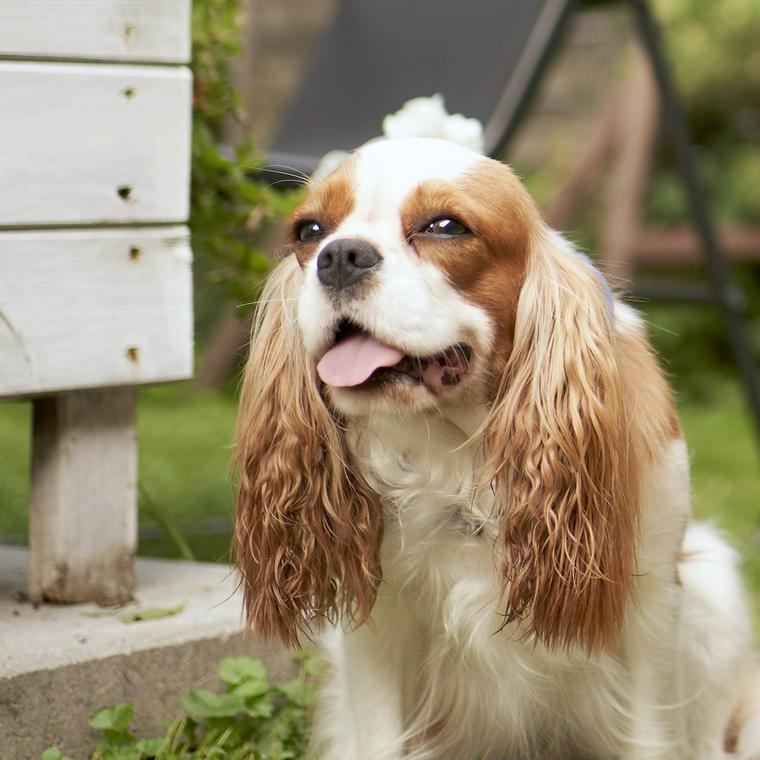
[236,139,635,649]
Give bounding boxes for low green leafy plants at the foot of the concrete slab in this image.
[41,650,321,760]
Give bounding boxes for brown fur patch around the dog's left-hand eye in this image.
[287,156,356,266]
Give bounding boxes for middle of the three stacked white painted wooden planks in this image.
[0,61,191,226]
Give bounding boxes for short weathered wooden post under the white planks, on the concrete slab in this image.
[29,389,137,604]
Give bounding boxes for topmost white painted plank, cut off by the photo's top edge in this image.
[0,0,190,63]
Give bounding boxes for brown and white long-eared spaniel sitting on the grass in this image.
[234,139,760,760]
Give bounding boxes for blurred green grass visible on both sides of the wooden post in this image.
[0,384,236,561]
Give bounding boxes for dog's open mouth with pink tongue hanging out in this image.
[317,319,472,391]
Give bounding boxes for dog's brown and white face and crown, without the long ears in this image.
[291,140,540,415]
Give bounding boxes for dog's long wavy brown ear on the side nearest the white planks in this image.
[234,256,382,645]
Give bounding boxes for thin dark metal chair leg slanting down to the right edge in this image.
[629,0,760,446]
